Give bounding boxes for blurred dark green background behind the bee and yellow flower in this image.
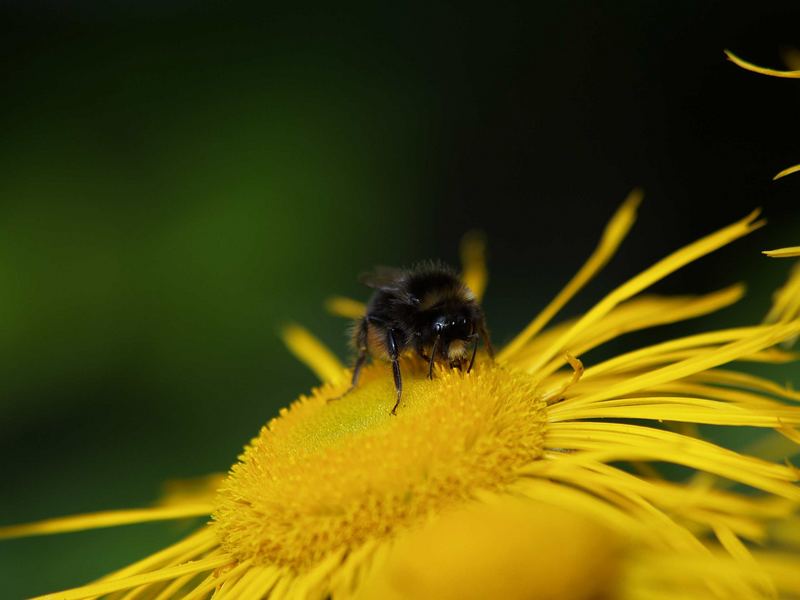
[0,0,800,598]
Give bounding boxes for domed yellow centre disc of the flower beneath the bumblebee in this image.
[214,358,546,569]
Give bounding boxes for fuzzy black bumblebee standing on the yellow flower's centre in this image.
[350,262,494,415]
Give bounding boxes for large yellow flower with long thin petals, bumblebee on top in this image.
[0,192,800,600]
